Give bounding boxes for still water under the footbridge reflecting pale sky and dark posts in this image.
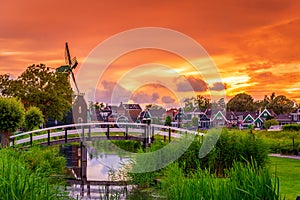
[60,143,132,199]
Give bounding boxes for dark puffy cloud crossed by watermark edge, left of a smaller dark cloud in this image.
[177,76,208,92]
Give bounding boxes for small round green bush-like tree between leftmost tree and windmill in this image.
[25,106,44,131]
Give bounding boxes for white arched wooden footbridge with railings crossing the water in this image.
[10,123,202,146]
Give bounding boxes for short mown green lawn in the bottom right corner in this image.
[270,157,300,200]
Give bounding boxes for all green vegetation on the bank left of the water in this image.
[0,148,68,200]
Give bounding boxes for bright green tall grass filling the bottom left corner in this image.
[0,149,68,200]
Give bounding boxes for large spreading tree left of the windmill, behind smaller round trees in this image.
[0,64,72,121]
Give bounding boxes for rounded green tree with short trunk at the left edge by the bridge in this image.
[0,97,24,147]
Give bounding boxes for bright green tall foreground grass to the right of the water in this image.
[161,161,280,200]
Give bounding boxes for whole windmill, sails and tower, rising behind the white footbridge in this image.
[56,42,87,123]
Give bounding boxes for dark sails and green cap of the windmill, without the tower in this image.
[56,42,79,94]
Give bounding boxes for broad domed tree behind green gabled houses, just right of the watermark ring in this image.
[227,93,255,112]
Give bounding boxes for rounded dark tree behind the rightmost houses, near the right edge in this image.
[268,95,294,115]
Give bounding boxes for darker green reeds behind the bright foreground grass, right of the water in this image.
[129,129,268,187]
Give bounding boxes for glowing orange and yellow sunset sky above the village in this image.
[0,0,300,107]
